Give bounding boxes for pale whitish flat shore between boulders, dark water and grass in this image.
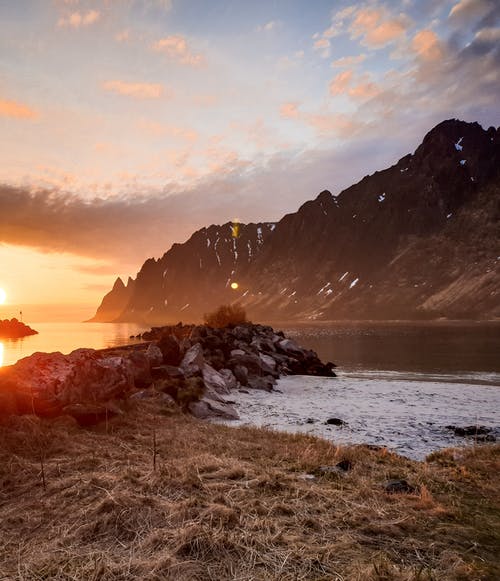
[224,372,500,460]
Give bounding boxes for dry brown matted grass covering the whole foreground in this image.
[0,402,500,581]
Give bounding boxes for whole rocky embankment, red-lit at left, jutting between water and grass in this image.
[0,323,335,424]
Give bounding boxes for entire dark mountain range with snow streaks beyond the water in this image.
[91,120,500,322]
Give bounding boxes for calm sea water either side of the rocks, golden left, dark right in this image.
[0,323,500,379]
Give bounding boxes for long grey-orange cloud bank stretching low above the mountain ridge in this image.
[0,136,400,274]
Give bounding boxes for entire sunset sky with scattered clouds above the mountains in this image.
[0,0,500,316]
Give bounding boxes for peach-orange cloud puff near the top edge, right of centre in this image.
[350,8,408,48]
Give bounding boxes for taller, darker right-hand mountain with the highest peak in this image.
[239,120,500,319]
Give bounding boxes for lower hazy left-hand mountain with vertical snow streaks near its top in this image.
[93,222,275,323]
